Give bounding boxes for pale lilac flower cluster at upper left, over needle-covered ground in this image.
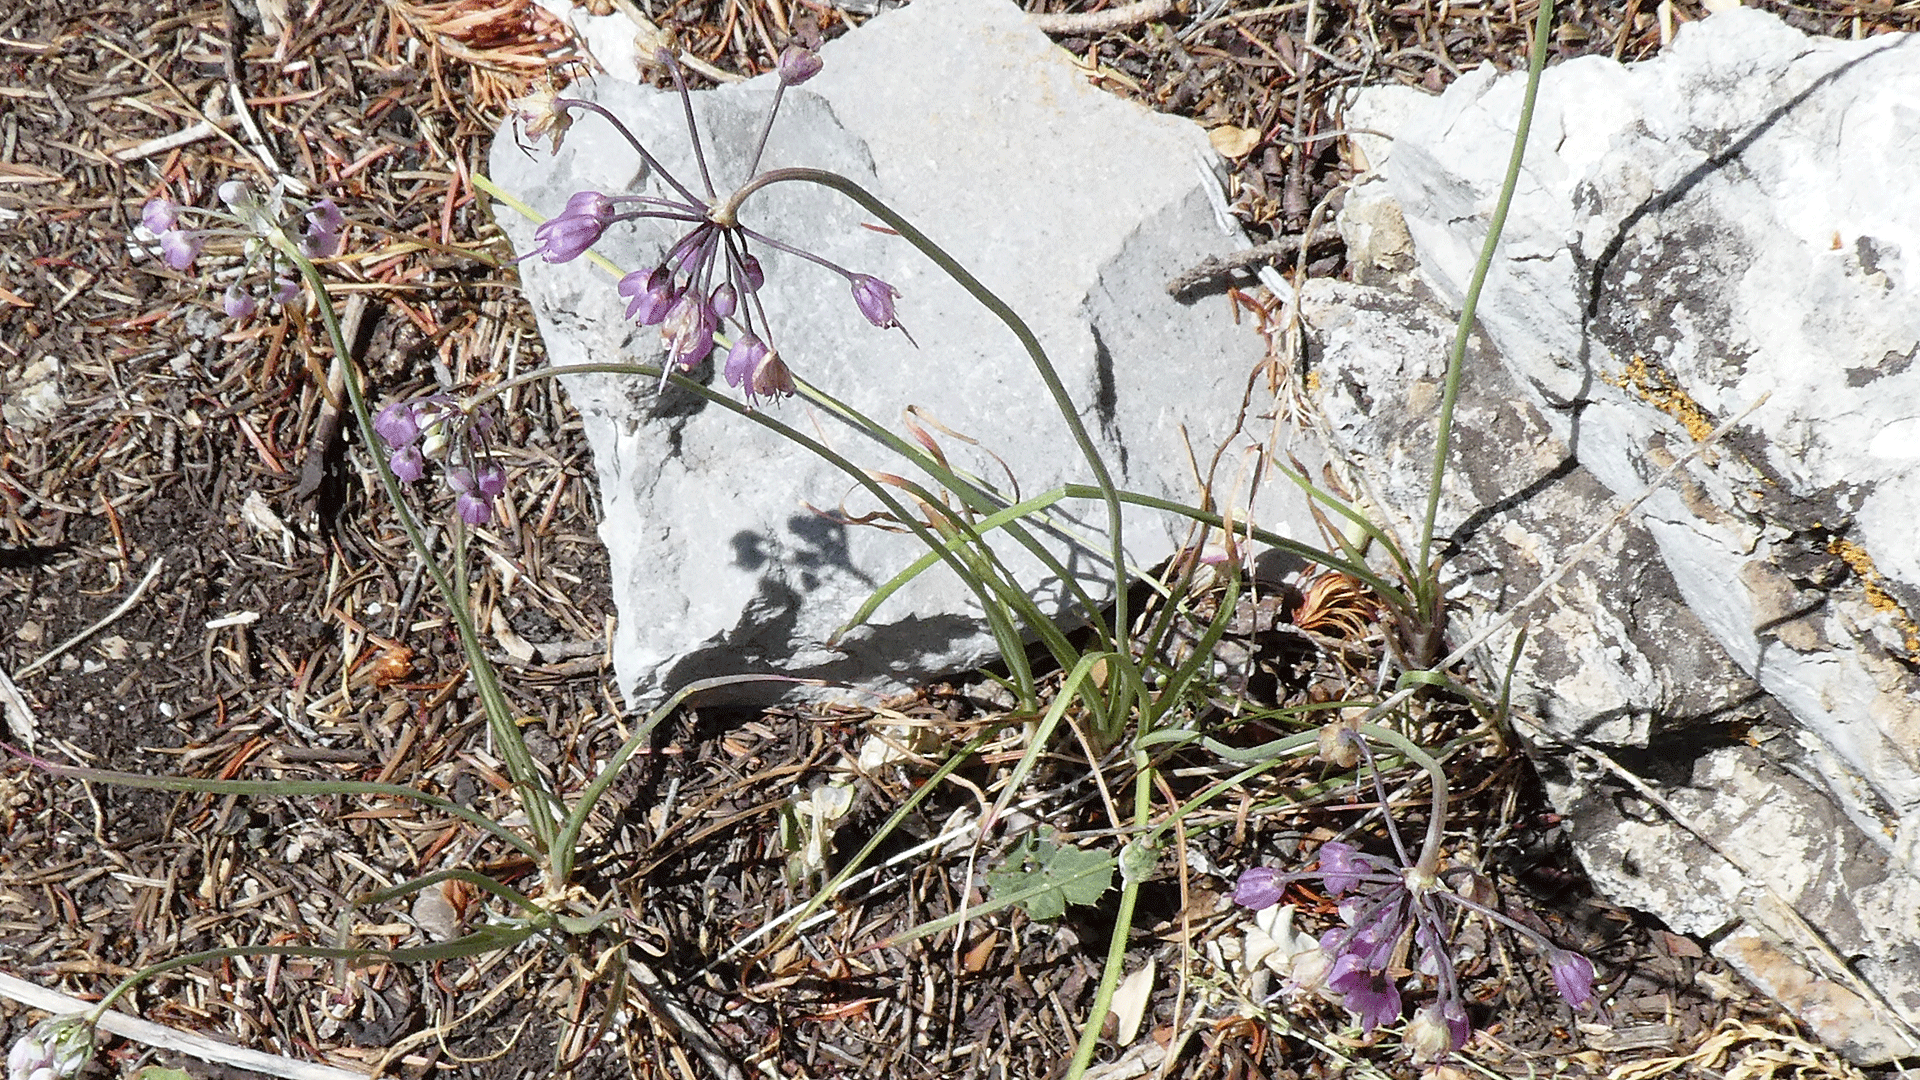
[140,181,346,319]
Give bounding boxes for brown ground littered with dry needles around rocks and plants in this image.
[0,0,1916,1080]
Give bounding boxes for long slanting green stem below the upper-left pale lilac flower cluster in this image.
[273,231,559,849]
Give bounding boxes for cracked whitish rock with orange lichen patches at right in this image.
[1328,10,1920,1063]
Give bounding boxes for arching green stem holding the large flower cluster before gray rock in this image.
[714,169,1133,667]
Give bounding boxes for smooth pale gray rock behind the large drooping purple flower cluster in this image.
[492,0,1297,703]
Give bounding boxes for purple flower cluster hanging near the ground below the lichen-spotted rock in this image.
[1233,732,1594,1061]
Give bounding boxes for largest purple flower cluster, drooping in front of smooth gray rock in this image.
[516,44,912,405]
